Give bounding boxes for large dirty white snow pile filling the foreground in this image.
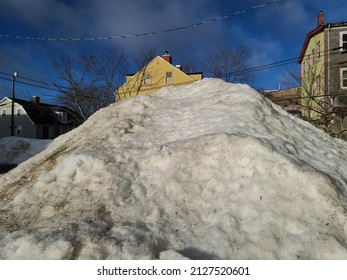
[0,79,347,259]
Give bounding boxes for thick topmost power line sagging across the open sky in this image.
[0,0,282,41]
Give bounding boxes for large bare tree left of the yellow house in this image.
[50,47,128,123]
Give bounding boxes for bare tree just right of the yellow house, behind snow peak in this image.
[204,45,252,83]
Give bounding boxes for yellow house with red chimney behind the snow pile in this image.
[115,52,202,101]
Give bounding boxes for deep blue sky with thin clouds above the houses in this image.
[0,0,347,102]
